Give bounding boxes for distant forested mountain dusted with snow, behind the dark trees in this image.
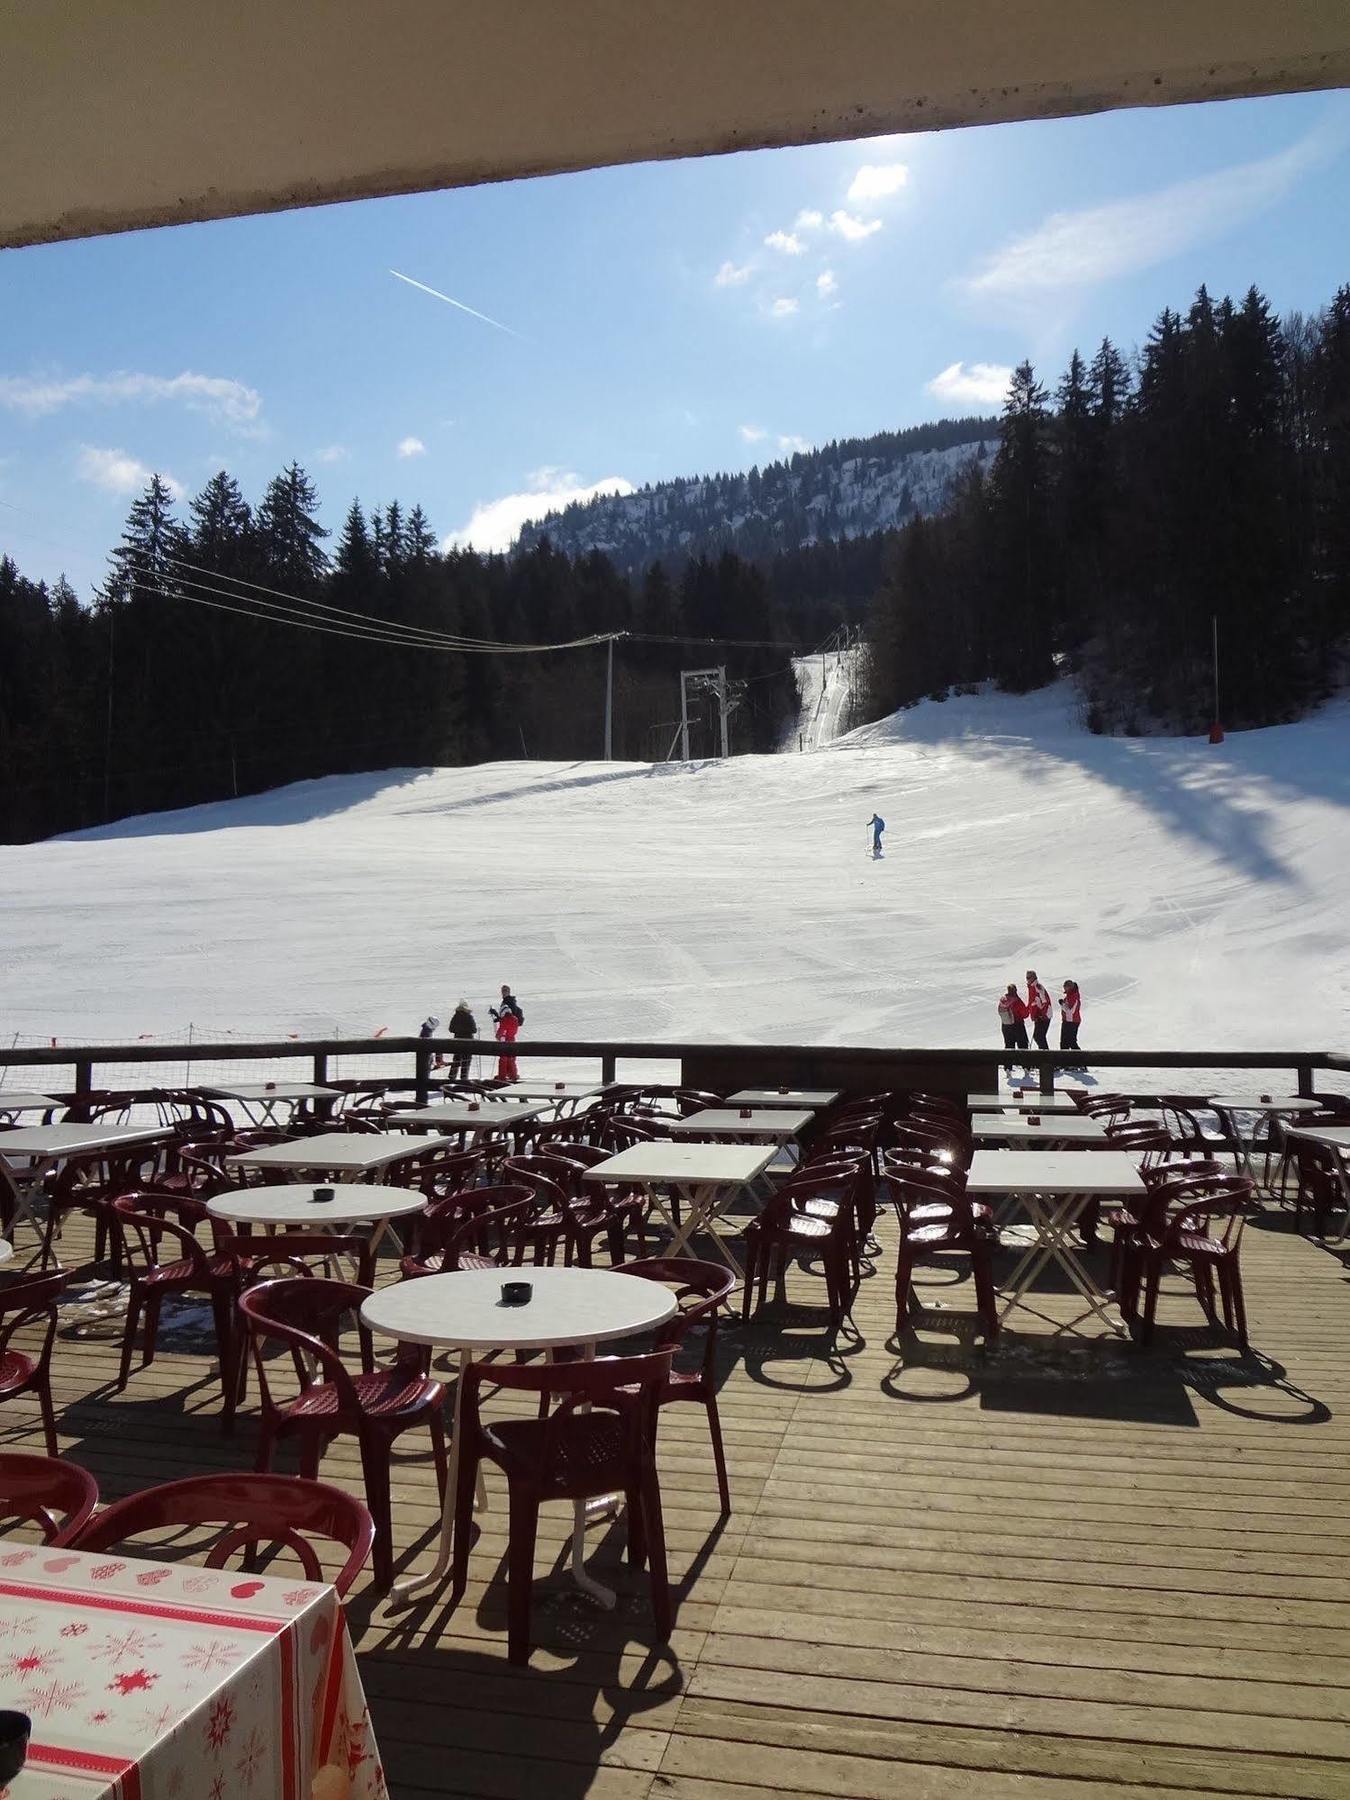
[517,419,997,574]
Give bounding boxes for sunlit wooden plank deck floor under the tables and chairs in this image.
[10,1220,1350,1800]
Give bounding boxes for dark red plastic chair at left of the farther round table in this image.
[112,1193,238,1397]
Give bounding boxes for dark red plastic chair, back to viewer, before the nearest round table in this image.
[452,1350,673,1663]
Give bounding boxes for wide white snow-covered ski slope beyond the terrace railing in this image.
[0,689,1350,1048]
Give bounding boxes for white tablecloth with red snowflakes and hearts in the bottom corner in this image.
[0,1537,387,1800]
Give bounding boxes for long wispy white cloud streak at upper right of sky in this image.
[963,133,1323,306]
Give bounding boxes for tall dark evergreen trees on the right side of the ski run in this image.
[868,286,1350,733]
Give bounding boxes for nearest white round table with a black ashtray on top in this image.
[362,1267,677,1607]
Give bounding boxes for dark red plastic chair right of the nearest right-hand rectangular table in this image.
[1121,1175,1256,1350]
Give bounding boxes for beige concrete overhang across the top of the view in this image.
[0,0,1350,245]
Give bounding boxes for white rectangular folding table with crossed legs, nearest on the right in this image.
[967,1150,1145,1334]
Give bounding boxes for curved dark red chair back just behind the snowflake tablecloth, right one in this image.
[68,1474,374,1595]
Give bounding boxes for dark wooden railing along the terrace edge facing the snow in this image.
[0,1037,1350,1103]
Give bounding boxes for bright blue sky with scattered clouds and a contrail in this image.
[0,94,1350,594]
